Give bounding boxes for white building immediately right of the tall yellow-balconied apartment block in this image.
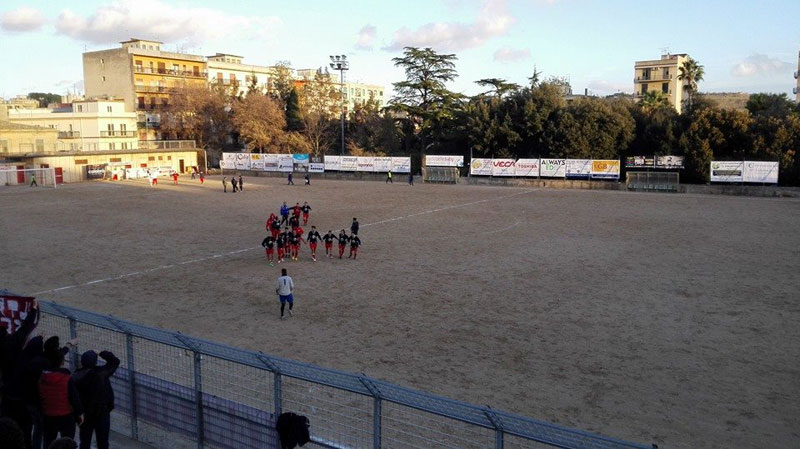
[208,53,273,96]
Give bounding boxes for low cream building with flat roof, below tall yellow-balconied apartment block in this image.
[8,99,139,152]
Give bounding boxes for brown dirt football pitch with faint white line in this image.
[0,176,800,448]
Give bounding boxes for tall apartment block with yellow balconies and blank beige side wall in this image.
[83,39,208,140]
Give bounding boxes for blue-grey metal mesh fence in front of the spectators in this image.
[14,293,650,449]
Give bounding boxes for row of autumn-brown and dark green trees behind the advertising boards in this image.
[162,47,800,185]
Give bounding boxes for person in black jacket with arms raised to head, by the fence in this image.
[72,350,119,449]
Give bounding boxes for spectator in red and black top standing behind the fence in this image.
[39,349,83,447]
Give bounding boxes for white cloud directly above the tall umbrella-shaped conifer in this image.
[386,0,514,51]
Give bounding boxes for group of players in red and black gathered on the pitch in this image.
[261,201,361,265]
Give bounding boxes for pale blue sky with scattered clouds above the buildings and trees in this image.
[0,0,800,98]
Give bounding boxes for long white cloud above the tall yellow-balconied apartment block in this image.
[56,0,283,45]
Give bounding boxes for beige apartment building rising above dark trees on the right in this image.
[633,53,689,113]
